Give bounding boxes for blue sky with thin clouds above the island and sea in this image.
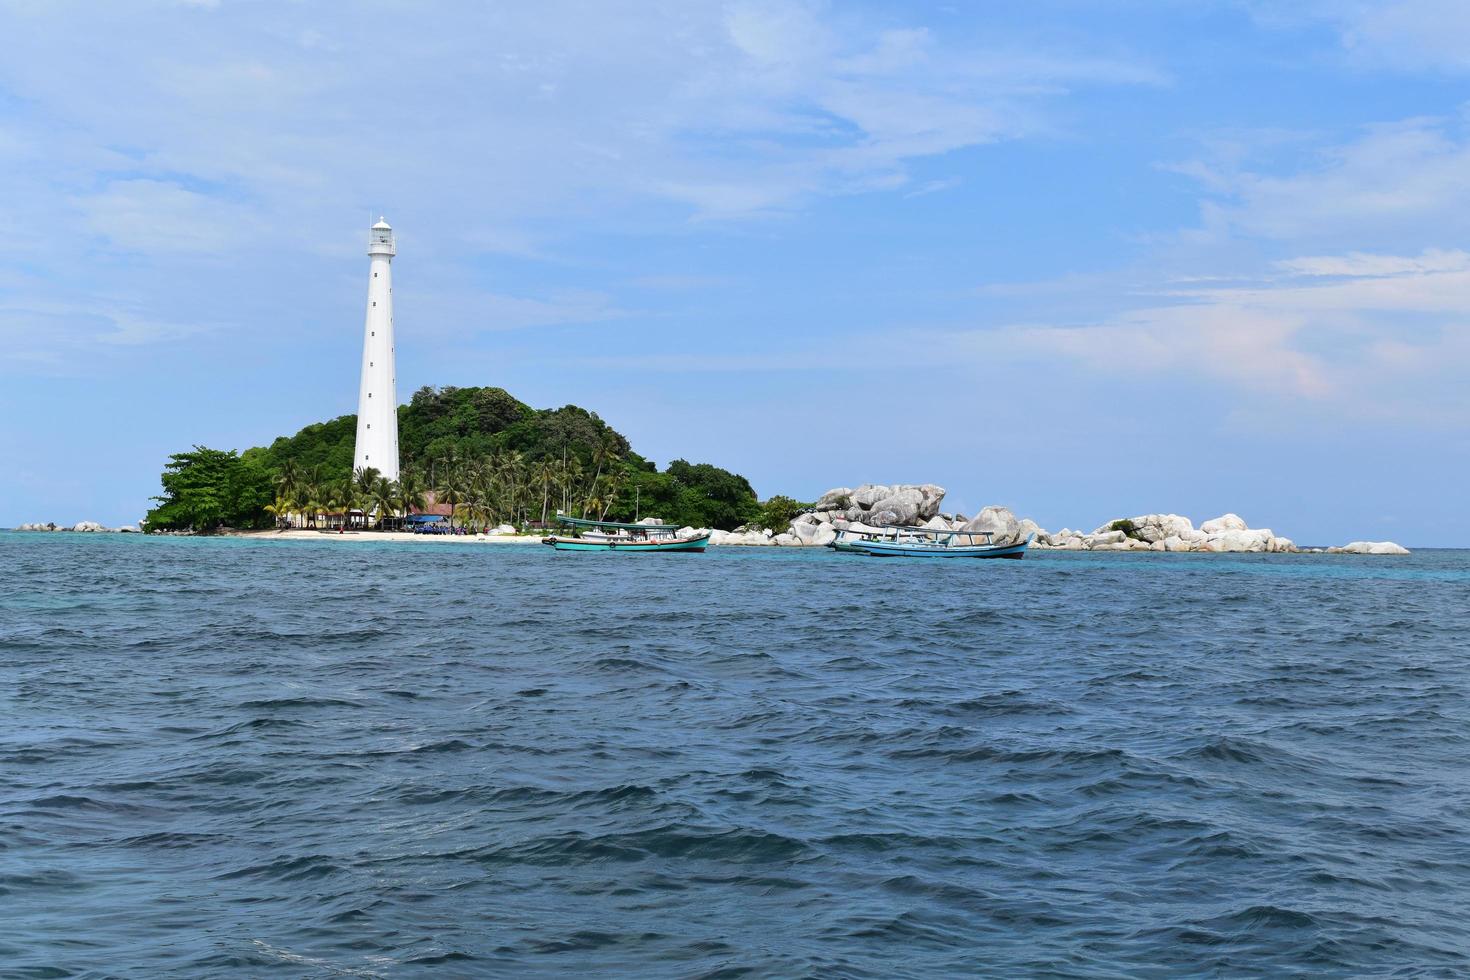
[0,0,1470,545]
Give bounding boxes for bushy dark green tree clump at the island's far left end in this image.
[147,445,275,532]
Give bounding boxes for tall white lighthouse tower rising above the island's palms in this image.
[353,217,398,480]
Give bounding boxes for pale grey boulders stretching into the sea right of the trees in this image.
[685,483,1408,555]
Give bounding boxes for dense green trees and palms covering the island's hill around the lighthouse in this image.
[148,388,761,529]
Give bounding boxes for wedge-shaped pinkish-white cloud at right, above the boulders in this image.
[950,250,1470,428]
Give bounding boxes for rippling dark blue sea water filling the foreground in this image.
[0,533,1470,977]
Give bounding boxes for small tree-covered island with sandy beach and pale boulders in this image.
[19,386,1408,555]
